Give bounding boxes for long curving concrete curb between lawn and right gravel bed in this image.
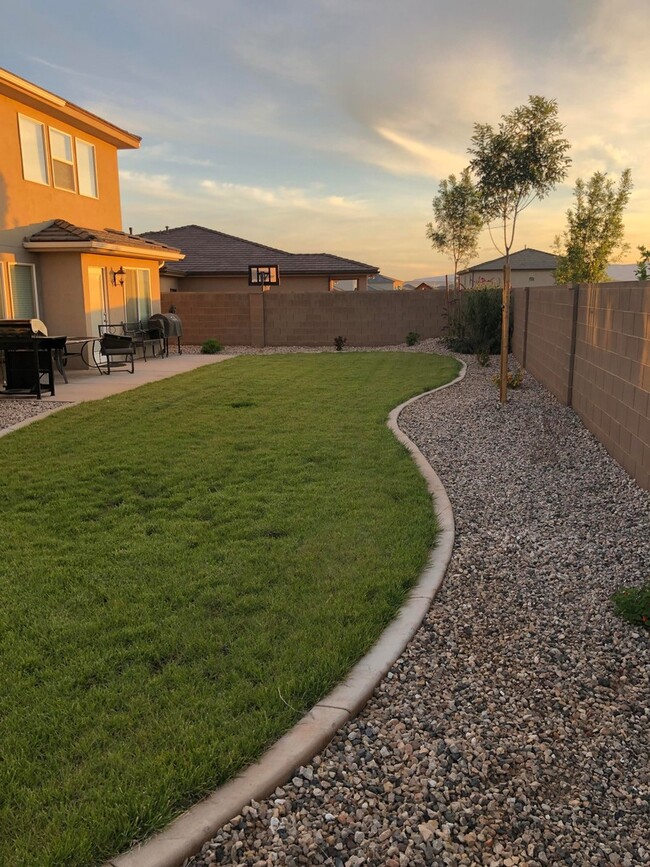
[103,362,467,867]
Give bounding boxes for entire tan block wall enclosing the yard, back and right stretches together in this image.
[161,281,650,490]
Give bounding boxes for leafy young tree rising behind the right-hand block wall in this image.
[555,169,632,283]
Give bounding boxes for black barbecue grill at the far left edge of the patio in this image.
[0,319,66,400]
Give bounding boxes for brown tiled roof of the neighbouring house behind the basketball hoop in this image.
[140,225,379,276]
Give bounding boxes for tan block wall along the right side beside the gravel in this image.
[513,282,650,490]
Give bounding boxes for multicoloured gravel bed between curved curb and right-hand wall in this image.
[186,341,650,867]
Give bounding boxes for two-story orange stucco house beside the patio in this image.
[0,69,183,336]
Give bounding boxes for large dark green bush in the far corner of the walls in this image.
[443,286,501,355]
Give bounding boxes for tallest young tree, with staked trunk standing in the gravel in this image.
[469,96,571,403]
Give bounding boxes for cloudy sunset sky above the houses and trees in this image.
[0,0,650,280]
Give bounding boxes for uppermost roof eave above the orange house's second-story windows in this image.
[0,68,141,149]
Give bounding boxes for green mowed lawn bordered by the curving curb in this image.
[0,353,458,867]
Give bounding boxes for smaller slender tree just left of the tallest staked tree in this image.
[427,168,483,289]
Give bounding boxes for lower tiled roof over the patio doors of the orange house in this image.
[23,220,183,260]
